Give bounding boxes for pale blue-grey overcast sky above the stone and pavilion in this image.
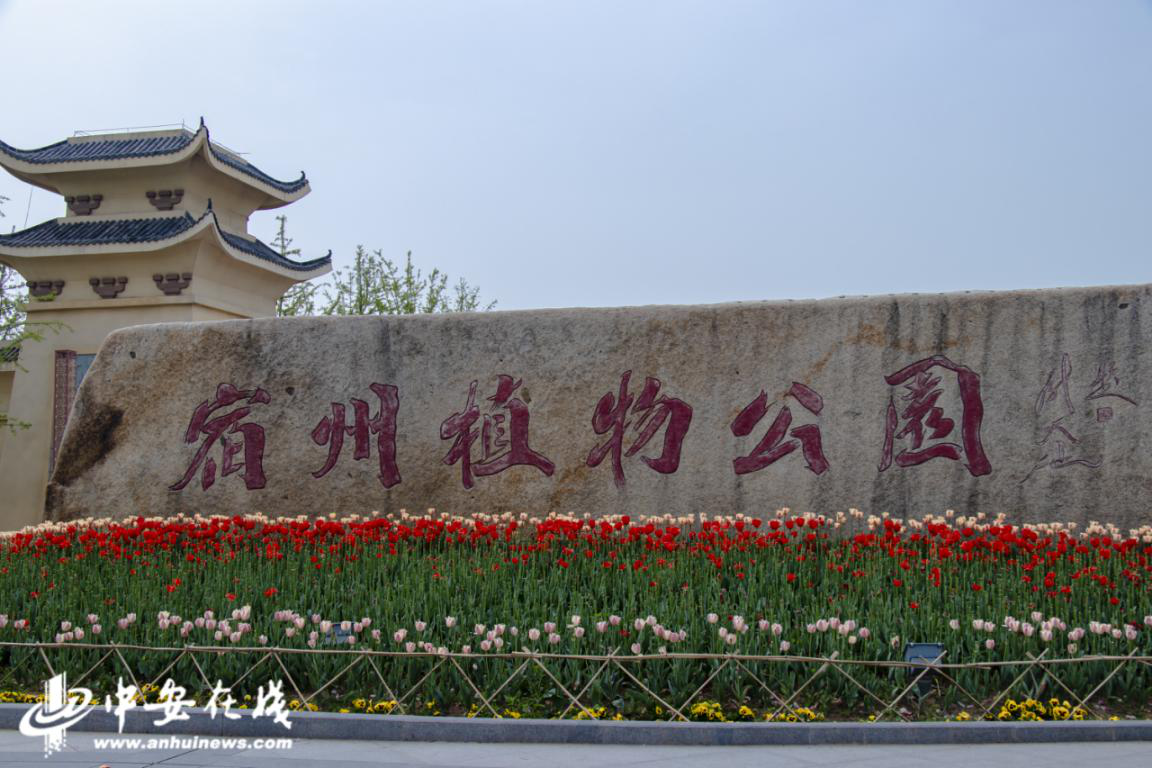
[0,0,1152,309]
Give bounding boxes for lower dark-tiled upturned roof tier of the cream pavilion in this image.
[0,207,332,280]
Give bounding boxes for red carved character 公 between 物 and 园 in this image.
[732,381,828,474]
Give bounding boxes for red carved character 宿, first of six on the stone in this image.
[169,383,271,491]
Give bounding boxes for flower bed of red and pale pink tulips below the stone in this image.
[0,510,1152,722]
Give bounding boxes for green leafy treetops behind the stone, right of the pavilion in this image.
[272,216,495,317]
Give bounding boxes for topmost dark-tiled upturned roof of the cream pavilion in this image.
[0,119,310,207]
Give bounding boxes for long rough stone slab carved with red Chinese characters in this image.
[47,286,1152,526]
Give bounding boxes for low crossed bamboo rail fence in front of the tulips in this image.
[0,641,1152,722]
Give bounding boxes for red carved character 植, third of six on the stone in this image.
[440,374,556,488]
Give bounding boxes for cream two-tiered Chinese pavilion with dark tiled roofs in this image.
[0,121,332,530]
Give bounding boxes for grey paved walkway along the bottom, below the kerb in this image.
[0,731,1152,768]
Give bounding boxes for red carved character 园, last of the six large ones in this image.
[880,355,992,477]
